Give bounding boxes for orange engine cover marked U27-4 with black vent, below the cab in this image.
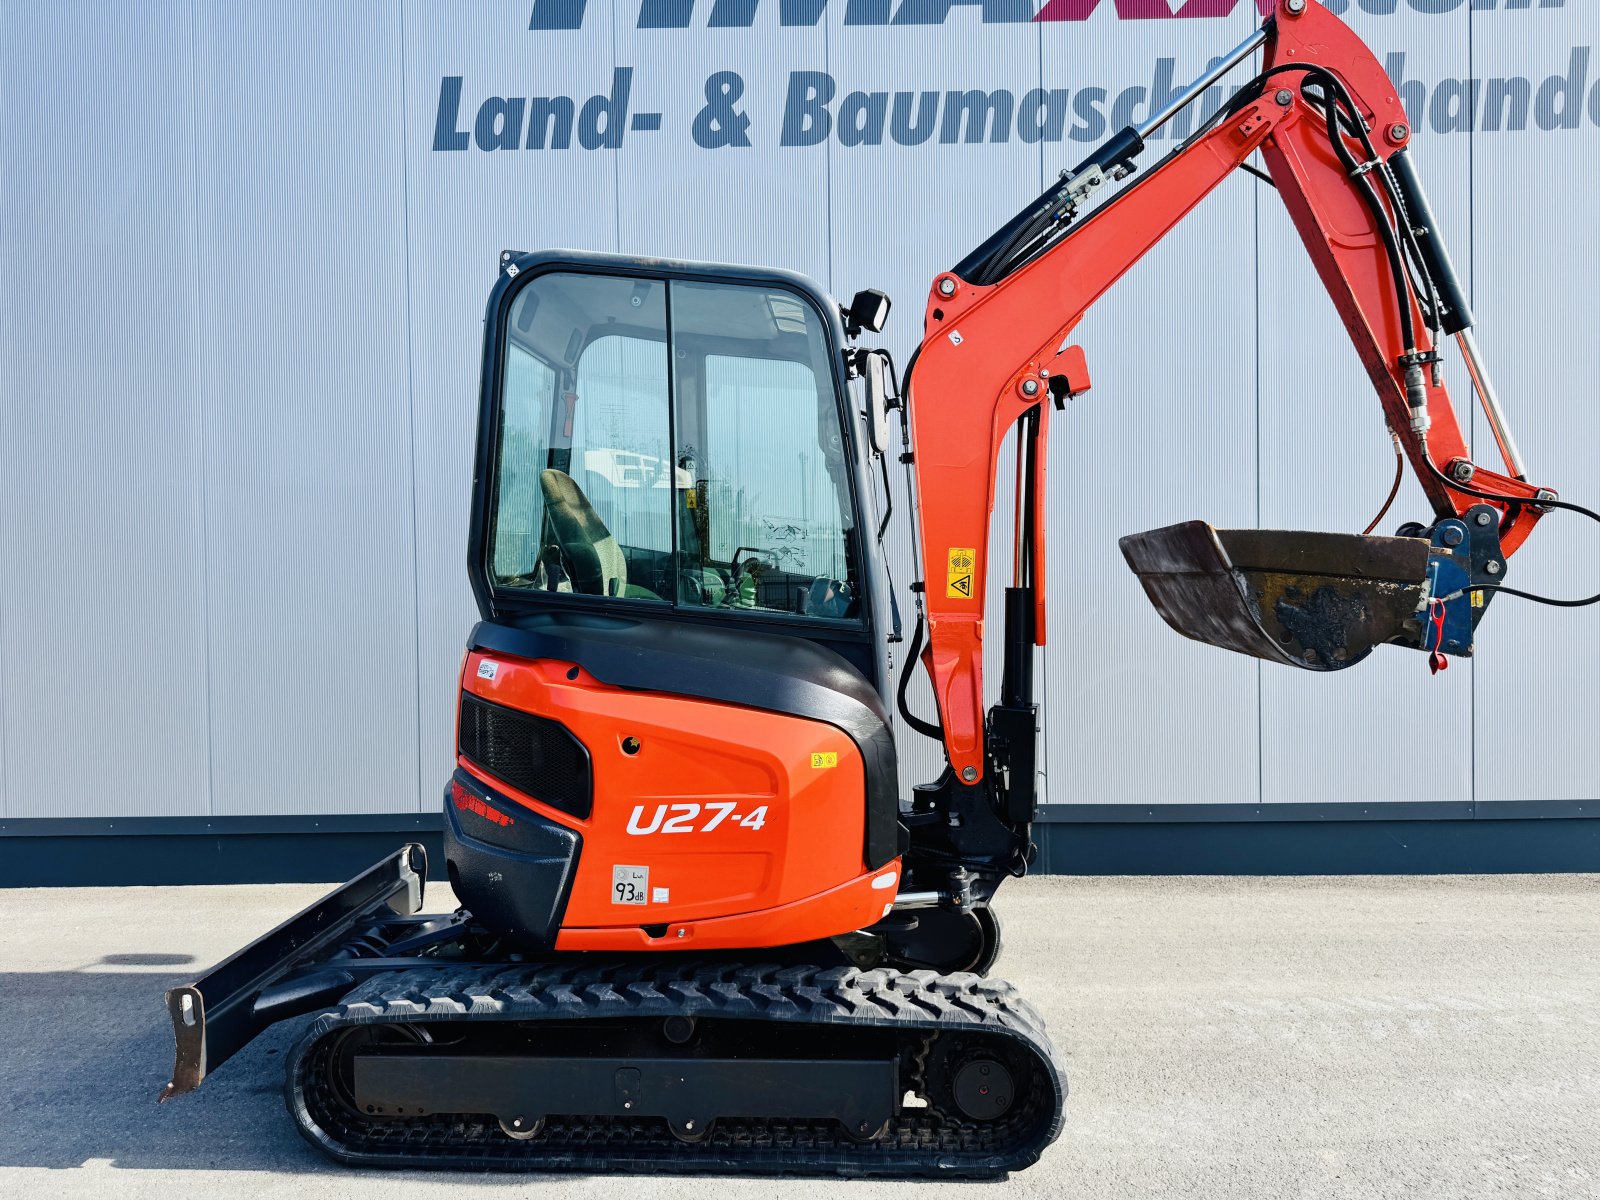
[446,614,899,949]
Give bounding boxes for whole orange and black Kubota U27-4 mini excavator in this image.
[163,0,1594,1178]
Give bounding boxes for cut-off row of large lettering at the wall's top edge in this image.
[528,0,1566,29]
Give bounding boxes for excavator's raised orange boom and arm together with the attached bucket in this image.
[907,0,1554,784]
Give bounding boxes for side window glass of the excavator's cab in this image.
[490,274,859,621]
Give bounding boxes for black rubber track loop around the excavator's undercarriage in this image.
[286,963,1066,1179]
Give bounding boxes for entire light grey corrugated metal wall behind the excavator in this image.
[0,0,1600,818]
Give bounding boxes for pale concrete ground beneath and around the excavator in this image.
[0,875,1600,1200]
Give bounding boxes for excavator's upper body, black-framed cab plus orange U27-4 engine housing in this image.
[445,251,928,950]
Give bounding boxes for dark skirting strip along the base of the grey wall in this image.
[0,800,1600,888]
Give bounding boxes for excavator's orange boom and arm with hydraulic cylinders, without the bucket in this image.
[907,0,1550,784]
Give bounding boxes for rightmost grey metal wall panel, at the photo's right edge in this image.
[1472,0,1600,802]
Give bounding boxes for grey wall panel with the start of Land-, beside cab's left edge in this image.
[405,0,616,808]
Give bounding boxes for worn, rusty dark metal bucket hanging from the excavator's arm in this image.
[1120,522,1430,670]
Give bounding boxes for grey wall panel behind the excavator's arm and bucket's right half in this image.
[1258,6,1472,803]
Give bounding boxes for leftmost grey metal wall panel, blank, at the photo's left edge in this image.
[0,3,208,816]
